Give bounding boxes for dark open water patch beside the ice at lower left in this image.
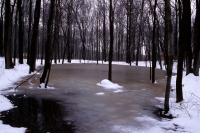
[0,95,75,133]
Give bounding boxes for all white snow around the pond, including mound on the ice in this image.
[0,58,200,133]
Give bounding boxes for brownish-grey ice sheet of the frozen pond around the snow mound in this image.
[4,64,166,133]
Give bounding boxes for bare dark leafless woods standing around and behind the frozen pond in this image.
[0,0,200,112]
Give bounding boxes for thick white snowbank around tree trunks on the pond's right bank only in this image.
[156,63,200,133]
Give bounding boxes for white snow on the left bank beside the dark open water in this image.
[0,57,40,133]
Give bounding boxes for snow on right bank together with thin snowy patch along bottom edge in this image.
[112,62,200,133]
